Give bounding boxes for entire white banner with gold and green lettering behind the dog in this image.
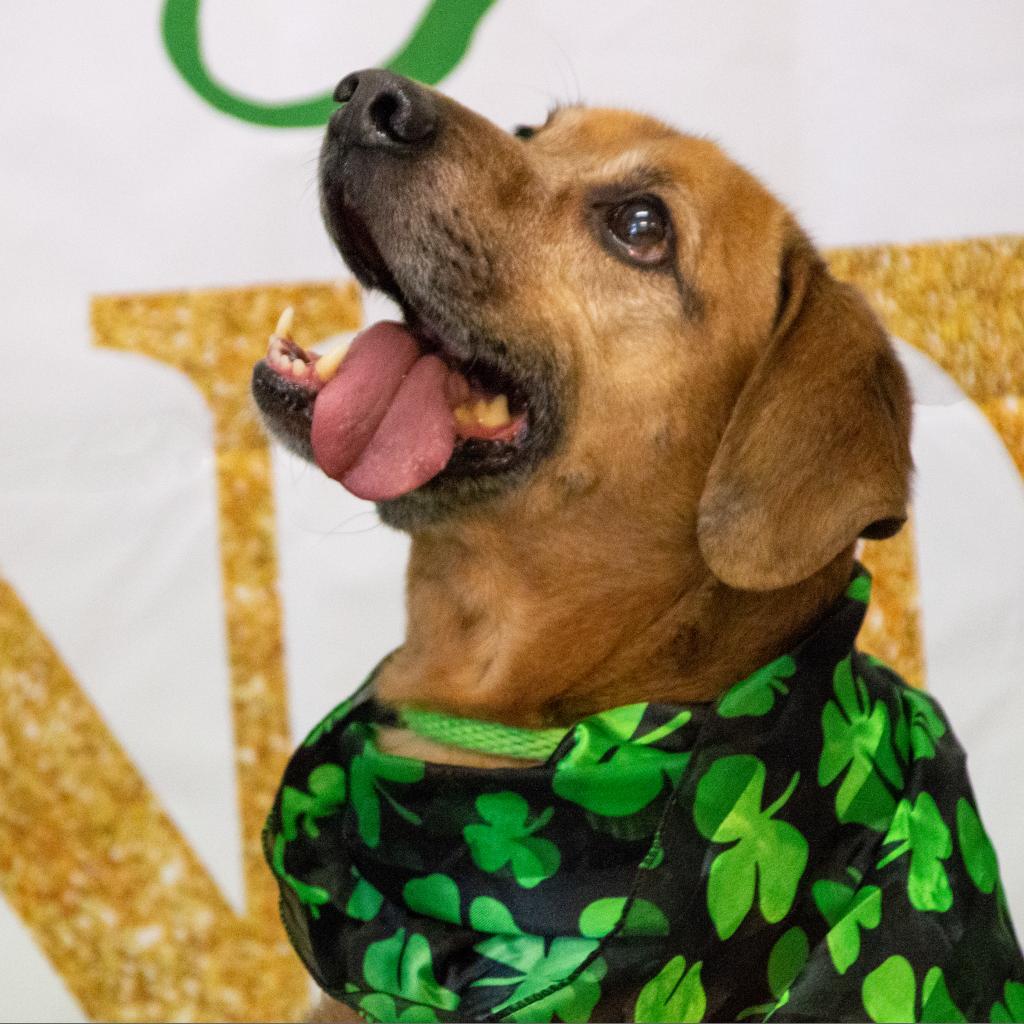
[0,0,1024,1021]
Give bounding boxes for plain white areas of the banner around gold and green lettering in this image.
[0,0,1024,1020]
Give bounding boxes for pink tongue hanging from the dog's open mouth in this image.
[311,322,455,502]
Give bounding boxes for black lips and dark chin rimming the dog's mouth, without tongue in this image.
[252,202,564,531]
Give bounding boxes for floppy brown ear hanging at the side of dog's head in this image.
[697,226,911,590]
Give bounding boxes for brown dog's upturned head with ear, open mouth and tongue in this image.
[254,71,910,590]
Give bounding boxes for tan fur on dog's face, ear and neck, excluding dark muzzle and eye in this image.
[364,104,909,726]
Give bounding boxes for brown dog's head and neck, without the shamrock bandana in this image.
[254,71,910,1019]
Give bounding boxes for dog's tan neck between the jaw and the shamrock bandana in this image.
[377,512,853,727]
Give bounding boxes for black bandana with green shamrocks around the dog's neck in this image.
[264,569,1024,1021]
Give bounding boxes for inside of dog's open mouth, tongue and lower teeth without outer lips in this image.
[251,311,529,502]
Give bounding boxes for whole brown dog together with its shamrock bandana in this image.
[253,71,1024,1021]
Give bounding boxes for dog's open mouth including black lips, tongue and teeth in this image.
[253,185,561,507]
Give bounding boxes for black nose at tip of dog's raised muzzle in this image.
[331,69,439,151]
